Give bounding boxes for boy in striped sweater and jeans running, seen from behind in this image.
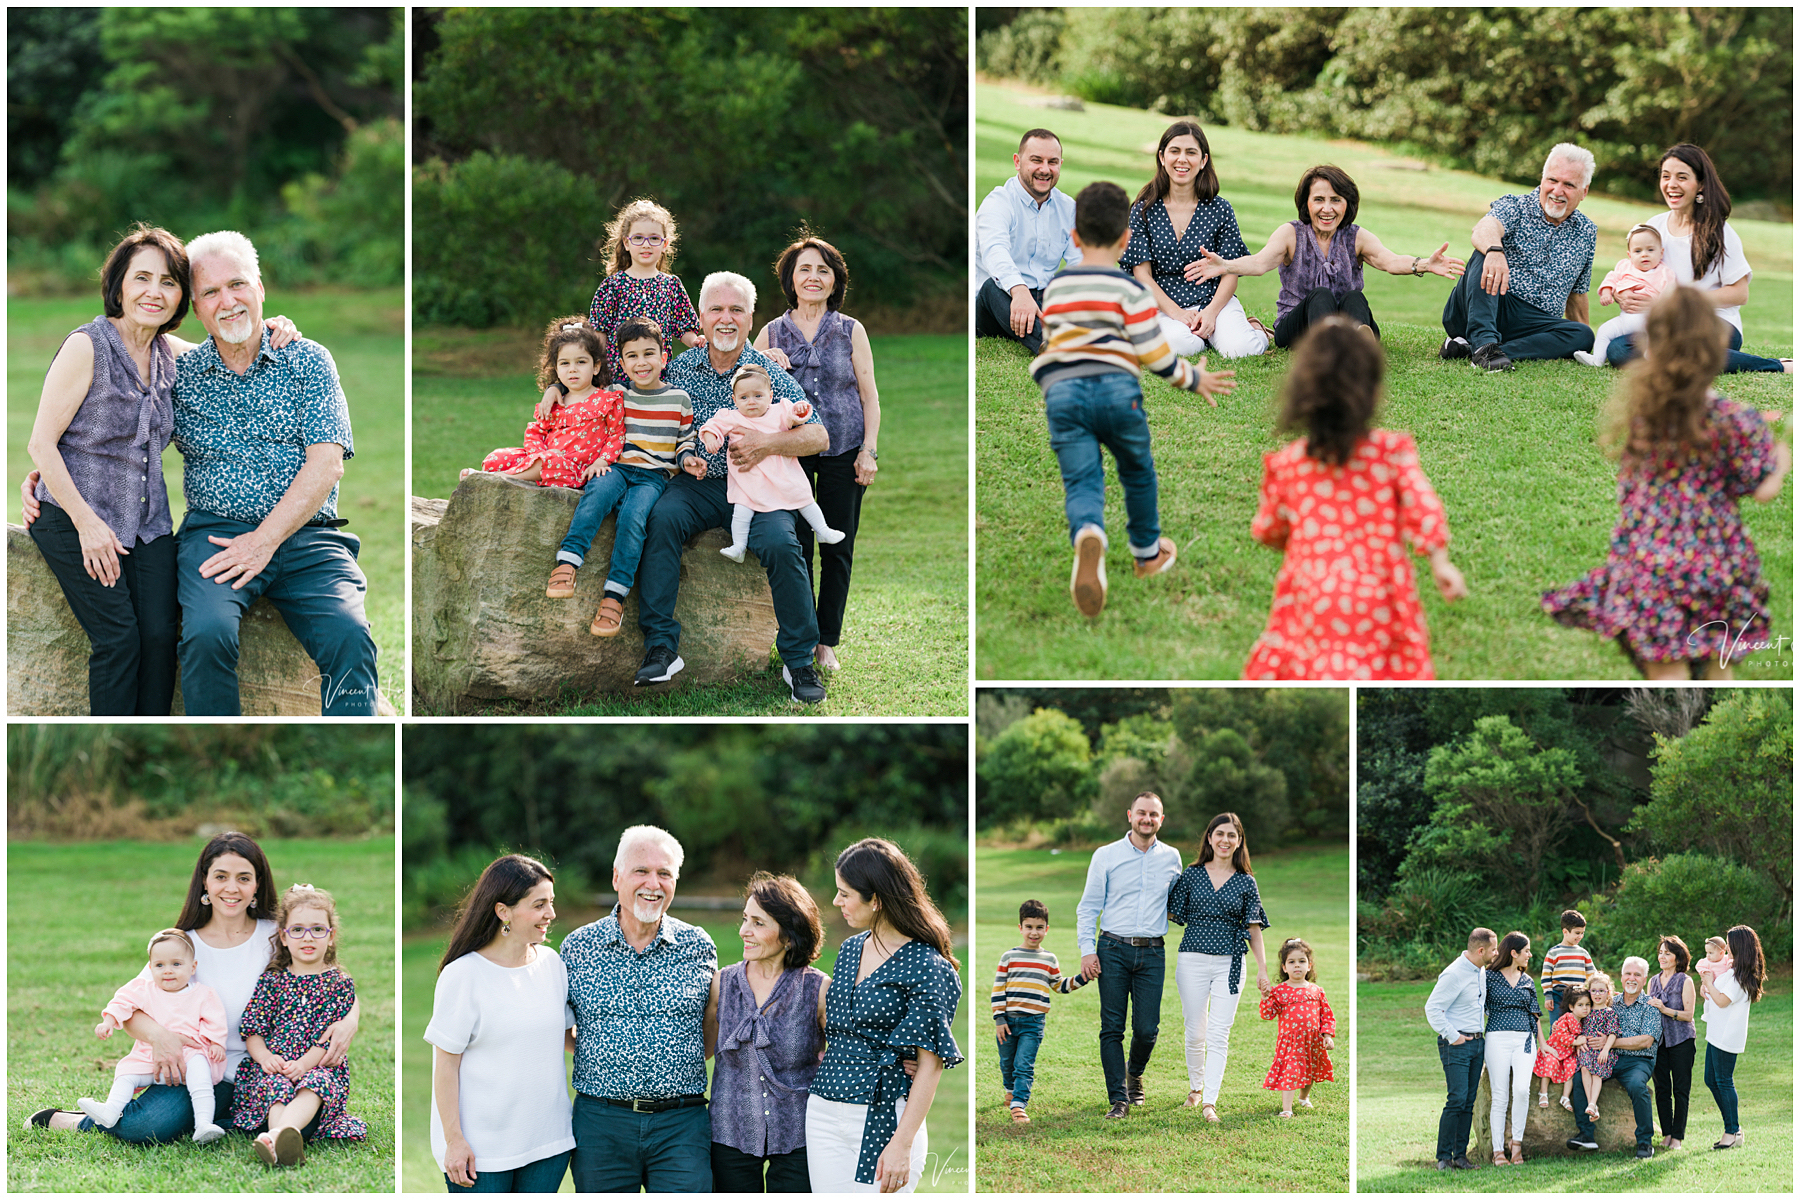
[1031,182,1237,617]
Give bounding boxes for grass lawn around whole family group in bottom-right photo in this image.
[1355,973,1795,1195]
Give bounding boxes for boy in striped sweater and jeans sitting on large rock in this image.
[545,320,706,637]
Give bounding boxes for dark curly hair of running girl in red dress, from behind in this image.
[1278,315,1386,466]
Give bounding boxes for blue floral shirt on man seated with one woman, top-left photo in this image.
[175,327,355,525]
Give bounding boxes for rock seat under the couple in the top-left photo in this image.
[5,525,394,716]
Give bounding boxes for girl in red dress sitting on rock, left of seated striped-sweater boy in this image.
[463,317,625,488]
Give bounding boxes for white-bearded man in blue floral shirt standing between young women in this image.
[562,826,718,1191]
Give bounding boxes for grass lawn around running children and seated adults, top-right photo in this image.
[976,86,1793,680]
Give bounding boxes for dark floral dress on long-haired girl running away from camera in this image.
[1543,394,1775,662]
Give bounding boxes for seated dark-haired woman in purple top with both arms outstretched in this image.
[1188,164,1463,349]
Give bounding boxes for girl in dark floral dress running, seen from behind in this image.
[1543,288,1793,680]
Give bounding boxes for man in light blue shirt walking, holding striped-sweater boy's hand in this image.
[1075,792,1181,1119]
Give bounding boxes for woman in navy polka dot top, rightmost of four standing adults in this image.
[806,838,963,1193]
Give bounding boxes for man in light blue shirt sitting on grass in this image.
[976,130,1080,354]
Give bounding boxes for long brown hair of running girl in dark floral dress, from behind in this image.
[1600,286,1728,466]
